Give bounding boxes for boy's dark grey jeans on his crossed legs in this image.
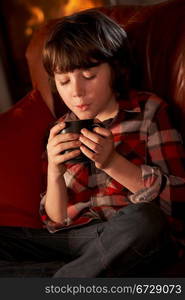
[0,203,174,278]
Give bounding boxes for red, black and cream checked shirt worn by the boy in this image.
[40,91,185,237]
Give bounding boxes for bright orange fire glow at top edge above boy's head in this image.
[63,0,102,16]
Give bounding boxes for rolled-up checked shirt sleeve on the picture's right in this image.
[130,100,185,227]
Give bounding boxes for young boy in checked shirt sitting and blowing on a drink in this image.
[0,10,185,278]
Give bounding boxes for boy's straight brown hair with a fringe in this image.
[43,9,132,99]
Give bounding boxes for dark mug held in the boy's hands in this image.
[59,119,104,163]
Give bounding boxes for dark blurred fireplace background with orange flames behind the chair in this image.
[0,0,170,112]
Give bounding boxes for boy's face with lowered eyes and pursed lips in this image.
[55,63,117,121]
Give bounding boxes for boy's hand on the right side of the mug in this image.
[79,127,116,169]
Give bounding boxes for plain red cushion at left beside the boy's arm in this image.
[0,91,54,227]
